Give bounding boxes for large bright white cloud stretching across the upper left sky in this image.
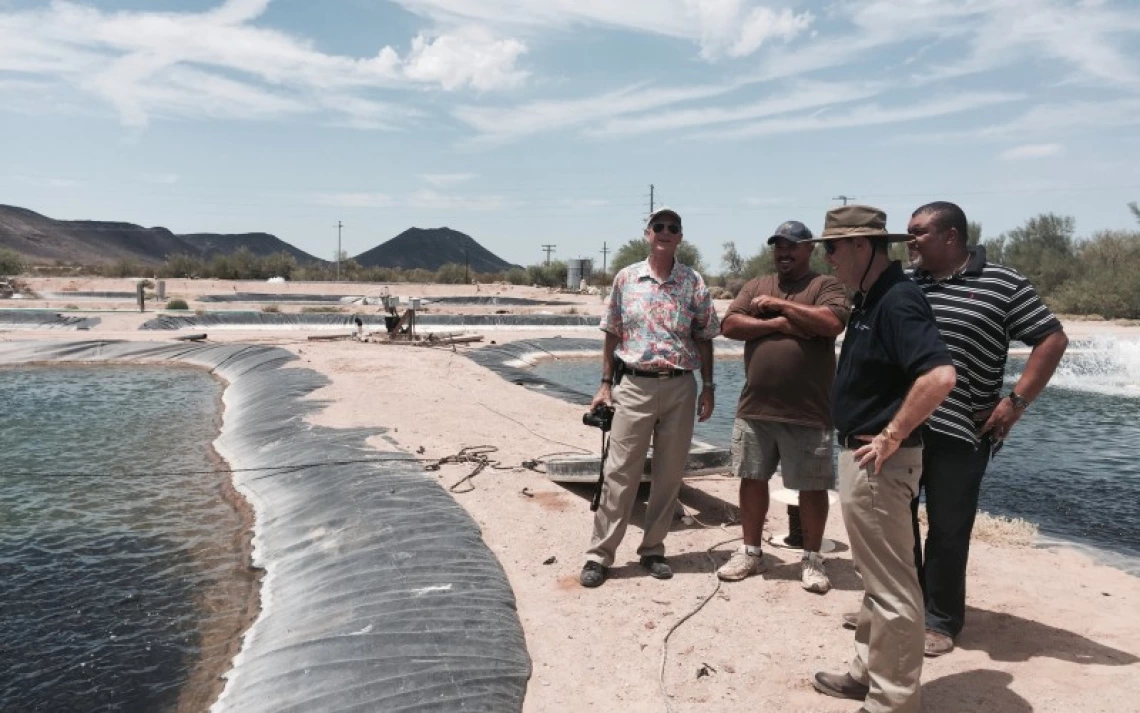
[0,0,527,128]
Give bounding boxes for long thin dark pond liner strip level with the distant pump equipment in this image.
[139,311,601,330]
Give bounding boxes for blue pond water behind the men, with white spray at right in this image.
[535,342,1140,558]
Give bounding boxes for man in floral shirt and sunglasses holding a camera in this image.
[579,208,720,586]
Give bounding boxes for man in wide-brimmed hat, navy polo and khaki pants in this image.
[812,205,955,713]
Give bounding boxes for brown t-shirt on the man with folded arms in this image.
[725,273,850,428]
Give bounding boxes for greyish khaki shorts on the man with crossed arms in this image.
[732,419,836,491]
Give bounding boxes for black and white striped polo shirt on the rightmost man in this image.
[911,245,1061,445]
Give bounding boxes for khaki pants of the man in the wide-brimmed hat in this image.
[839,447,925,713]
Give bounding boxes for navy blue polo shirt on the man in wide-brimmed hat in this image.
[831,260,954,439]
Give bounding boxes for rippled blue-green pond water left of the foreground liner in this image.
[0,366,255,712]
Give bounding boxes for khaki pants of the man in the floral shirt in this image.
[586,374,697,567]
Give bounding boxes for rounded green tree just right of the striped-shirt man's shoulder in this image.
[1002,213,1075,294]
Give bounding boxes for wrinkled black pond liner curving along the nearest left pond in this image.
[0,341,530,713]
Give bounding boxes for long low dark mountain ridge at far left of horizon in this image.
[0,205,321,265]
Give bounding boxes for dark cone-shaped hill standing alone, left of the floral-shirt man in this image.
[353,227,518,273]
